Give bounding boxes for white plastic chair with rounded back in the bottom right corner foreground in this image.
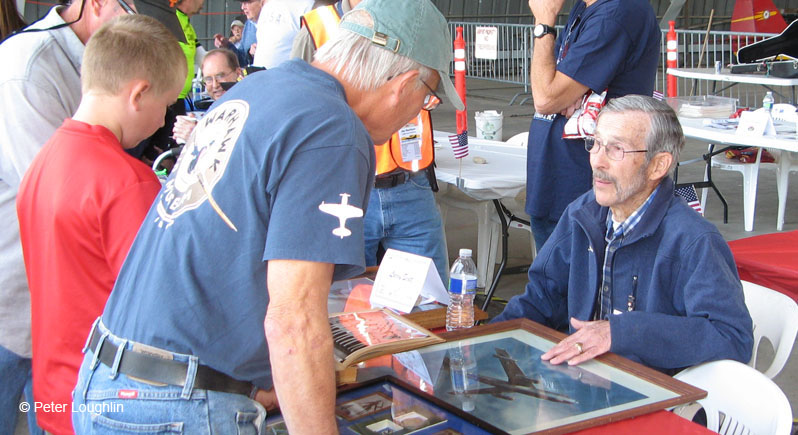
[674,360,792,435]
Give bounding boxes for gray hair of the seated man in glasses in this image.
[598,95,684,169]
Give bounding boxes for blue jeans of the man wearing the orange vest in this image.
[364,171,449,286]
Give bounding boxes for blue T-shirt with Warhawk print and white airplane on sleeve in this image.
[103,60,374,388]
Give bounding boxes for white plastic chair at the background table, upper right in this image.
[701,104,798,231]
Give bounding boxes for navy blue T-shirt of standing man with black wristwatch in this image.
[526,0,660,221]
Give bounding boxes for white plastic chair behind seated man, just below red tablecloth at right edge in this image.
[742,281,798,379]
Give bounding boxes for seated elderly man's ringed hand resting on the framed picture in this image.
[540,317,612,365]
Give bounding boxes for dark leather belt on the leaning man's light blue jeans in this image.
[89,328,253,396]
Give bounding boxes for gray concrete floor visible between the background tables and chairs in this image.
[433,79,798,433]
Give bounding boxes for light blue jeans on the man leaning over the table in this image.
[72,322,266,434]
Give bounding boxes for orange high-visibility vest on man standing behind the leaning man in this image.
[300,5,435,175]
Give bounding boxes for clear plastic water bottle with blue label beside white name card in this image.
[446,249,477,331]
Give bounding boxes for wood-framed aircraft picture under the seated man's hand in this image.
[384,319,706,434]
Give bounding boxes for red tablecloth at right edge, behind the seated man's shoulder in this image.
[729,231,798,301]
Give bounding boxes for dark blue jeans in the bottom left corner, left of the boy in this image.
[0,346,44,435]
